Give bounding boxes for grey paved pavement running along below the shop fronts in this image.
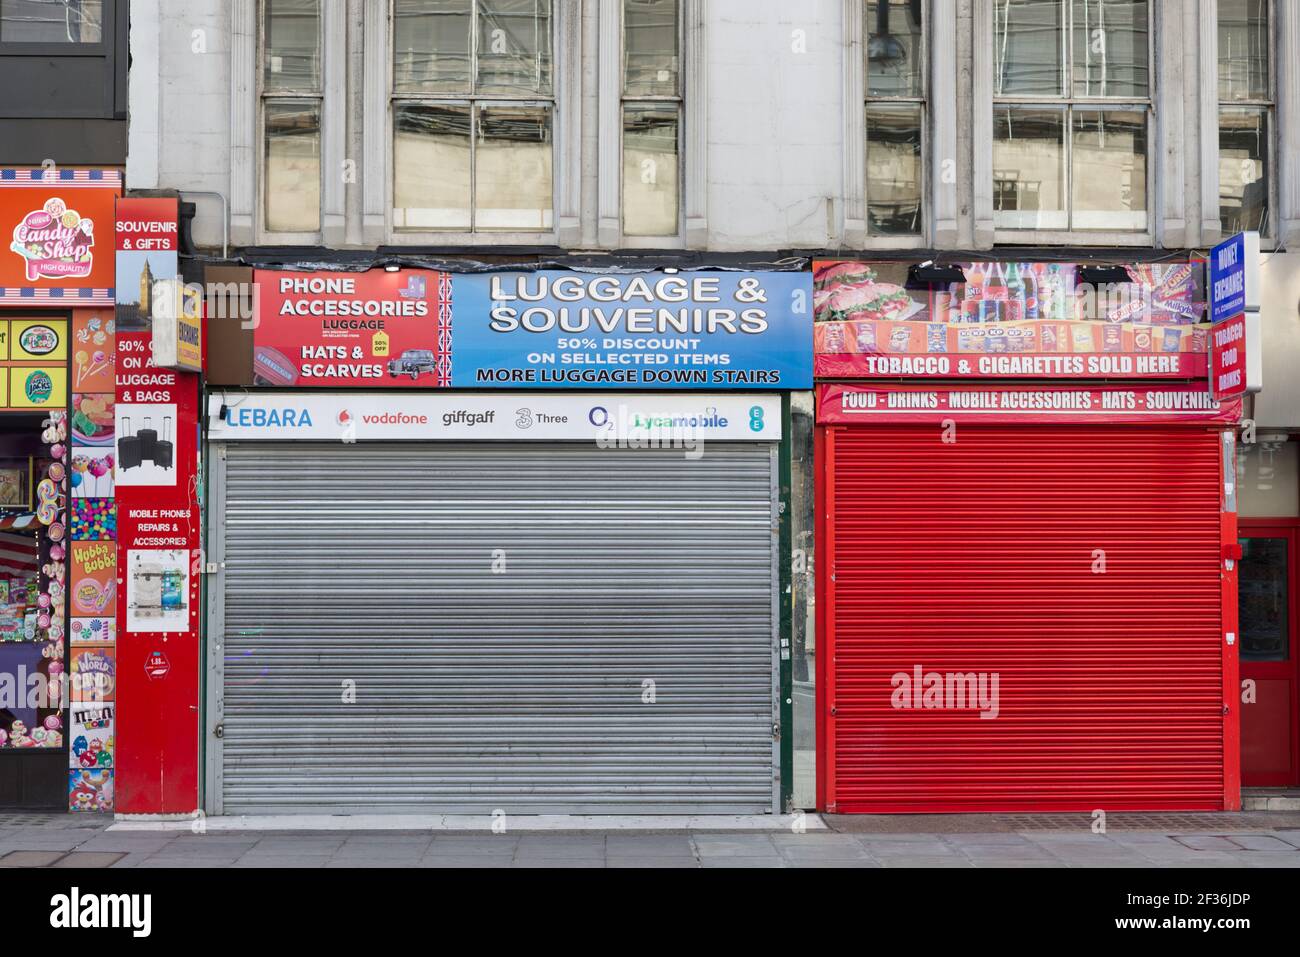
[0,814,1300,869]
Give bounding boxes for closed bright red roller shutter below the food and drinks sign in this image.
[822,425,1225,813]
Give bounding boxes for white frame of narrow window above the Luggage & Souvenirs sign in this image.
[597,0,709,250]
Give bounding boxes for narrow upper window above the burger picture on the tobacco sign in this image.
[863,0,926,235]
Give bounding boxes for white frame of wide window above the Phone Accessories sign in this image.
[361,0,581,247]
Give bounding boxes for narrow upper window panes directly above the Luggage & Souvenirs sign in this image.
[621,0,683,237]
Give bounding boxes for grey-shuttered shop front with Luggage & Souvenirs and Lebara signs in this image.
[204,263,811,814]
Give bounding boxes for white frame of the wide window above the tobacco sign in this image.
[971,0,1159,248]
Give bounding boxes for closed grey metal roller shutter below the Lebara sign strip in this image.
[211,443,776,814]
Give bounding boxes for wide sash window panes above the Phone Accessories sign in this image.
[391,0,555,233]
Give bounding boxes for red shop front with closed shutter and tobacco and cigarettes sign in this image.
[815,263,1240,813]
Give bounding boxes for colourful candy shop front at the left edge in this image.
[0,169,121,810]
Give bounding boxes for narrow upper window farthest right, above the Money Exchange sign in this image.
[1218,0,1274,235]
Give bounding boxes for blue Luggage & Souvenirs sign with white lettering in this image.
[451,270,813,390]
